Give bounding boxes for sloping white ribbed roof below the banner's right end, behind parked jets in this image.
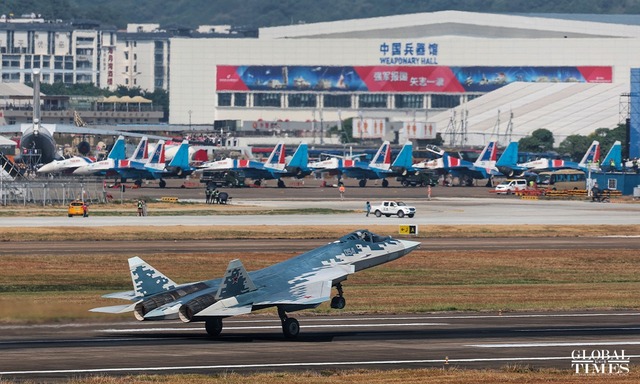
[429,83,629,145]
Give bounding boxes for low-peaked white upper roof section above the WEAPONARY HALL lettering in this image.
[259,11,640,39]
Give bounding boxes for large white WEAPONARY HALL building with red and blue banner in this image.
[169,11,640,150]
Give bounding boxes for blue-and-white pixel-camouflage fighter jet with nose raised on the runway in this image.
[91,230,420,338]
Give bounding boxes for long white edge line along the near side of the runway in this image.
[0,356,600,375]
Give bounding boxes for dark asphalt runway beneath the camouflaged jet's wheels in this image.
[0,311,640,380]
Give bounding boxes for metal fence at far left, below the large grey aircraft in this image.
[0,178,107,206]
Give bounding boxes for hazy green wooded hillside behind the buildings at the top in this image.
[0,0,640,28]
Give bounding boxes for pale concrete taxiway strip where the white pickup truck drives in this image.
[0,198,640,228]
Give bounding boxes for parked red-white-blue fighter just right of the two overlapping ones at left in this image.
[199,142,311,188]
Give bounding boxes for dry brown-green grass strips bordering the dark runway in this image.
[0,226,640,384]
